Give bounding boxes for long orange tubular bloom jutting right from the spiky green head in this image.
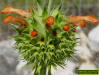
[69,15,99,27]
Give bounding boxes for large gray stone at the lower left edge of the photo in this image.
[0,39,18,75]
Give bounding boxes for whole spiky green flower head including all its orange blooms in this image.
[0,0,99,75]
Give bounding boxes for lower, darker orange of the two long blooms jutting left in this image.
[3,15,28,27]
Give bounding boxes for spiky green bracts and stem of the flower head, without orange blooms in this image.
[14,0,77,75]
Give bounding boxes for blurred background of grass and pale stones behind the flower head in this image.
[0,0,99,75]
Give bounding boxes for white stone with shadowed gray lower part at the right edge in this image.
[88,25,99,69]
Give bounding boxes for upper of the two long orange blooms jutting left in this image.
[0,6,29,17]
